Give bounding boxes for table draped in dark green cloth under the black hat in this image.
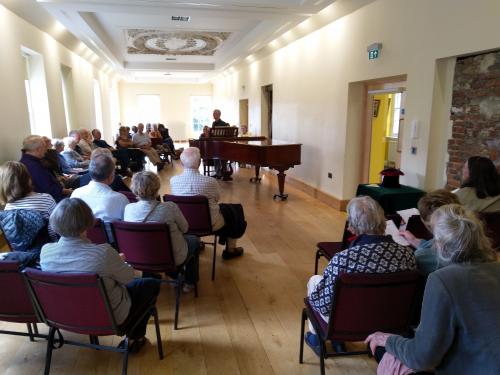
[356,184,425,214]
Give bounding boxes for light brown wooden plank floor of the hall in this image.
[0,162,376,375]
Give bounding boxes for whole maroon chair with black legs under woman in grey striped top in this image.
[25,268,163,375]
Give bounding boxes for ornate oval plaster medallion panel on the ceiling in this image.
[126,29,231,56]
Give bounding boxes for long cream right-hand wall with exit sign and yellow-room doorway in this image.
[214,0,500,199]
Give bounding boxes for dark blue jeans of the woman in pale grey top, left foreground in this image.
[126,277,160,340]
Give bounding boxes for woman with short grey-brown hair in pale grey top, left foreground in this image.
[40,198,160,353]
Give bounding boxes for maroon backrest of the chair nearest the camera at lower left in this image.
[25,268,117,336]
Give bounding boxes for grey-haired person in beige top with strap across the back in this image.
[123,171,200,292]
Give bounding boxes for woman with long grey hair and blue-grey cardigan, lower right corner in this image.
[365,204,500,375]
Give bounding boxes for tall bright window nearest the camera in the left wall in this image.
[21,47,52,138]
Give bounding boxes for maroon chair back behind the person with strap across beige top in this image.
[111,221,177,273]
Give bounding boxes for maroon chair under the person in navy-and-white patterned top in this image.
[299,271,420,375]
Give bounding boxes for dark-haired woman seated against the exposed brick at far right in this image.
[454,156,500,212]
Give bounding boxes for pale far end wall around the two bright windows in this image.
[120,82,215,140]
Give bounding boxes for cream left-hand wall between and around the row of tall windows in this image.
[0,5,117,162]
